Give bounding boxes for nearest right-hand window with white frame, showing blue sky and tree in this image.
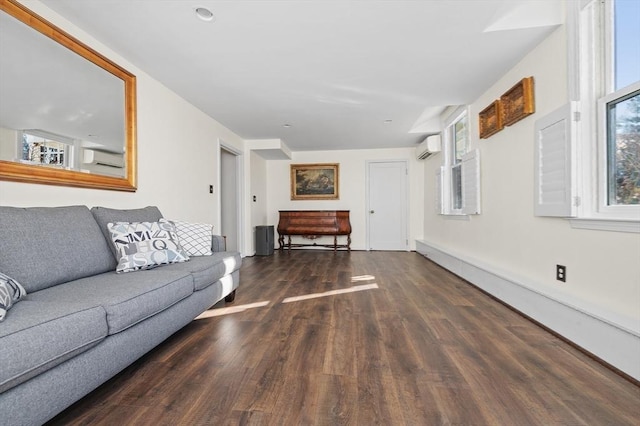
[568,0,640,232]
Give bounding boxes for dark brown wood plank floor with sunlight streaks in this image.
[50,250,640,426]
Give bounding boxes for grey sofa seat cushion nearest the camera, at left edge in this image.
[0,302,108,394]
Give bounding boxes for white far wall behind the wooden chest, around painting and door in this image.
[267,148,424,250]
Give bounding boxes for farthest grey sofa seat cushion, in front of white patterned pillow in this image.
[169,251,242,291]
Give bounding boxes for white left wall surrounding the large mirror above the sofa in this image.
[0,1,244,228]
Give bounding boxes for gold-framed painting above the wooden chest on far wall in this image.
[291,163,340,200]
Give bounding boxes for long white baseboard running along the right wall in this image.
[416,240,640,380]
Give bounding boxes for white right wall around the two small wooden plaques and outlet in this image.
[424,27,640,375]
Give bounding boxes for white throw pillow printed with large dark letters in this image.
[107,222,189,272]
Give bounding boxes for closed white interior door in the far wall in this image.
[367,160,409,250]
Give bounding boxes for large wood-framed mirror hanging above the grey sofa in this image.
[0,0,137,192]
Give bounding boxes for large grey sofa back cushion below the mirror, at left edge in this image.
[0,206,116,293]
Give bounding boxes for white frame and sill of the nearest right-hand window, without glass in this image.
[567,0,640,232]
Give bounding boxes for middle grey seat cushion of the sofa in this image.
[25,266,193,335]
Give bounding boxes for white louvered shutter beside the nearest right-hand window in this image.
[534,103,576,217]
